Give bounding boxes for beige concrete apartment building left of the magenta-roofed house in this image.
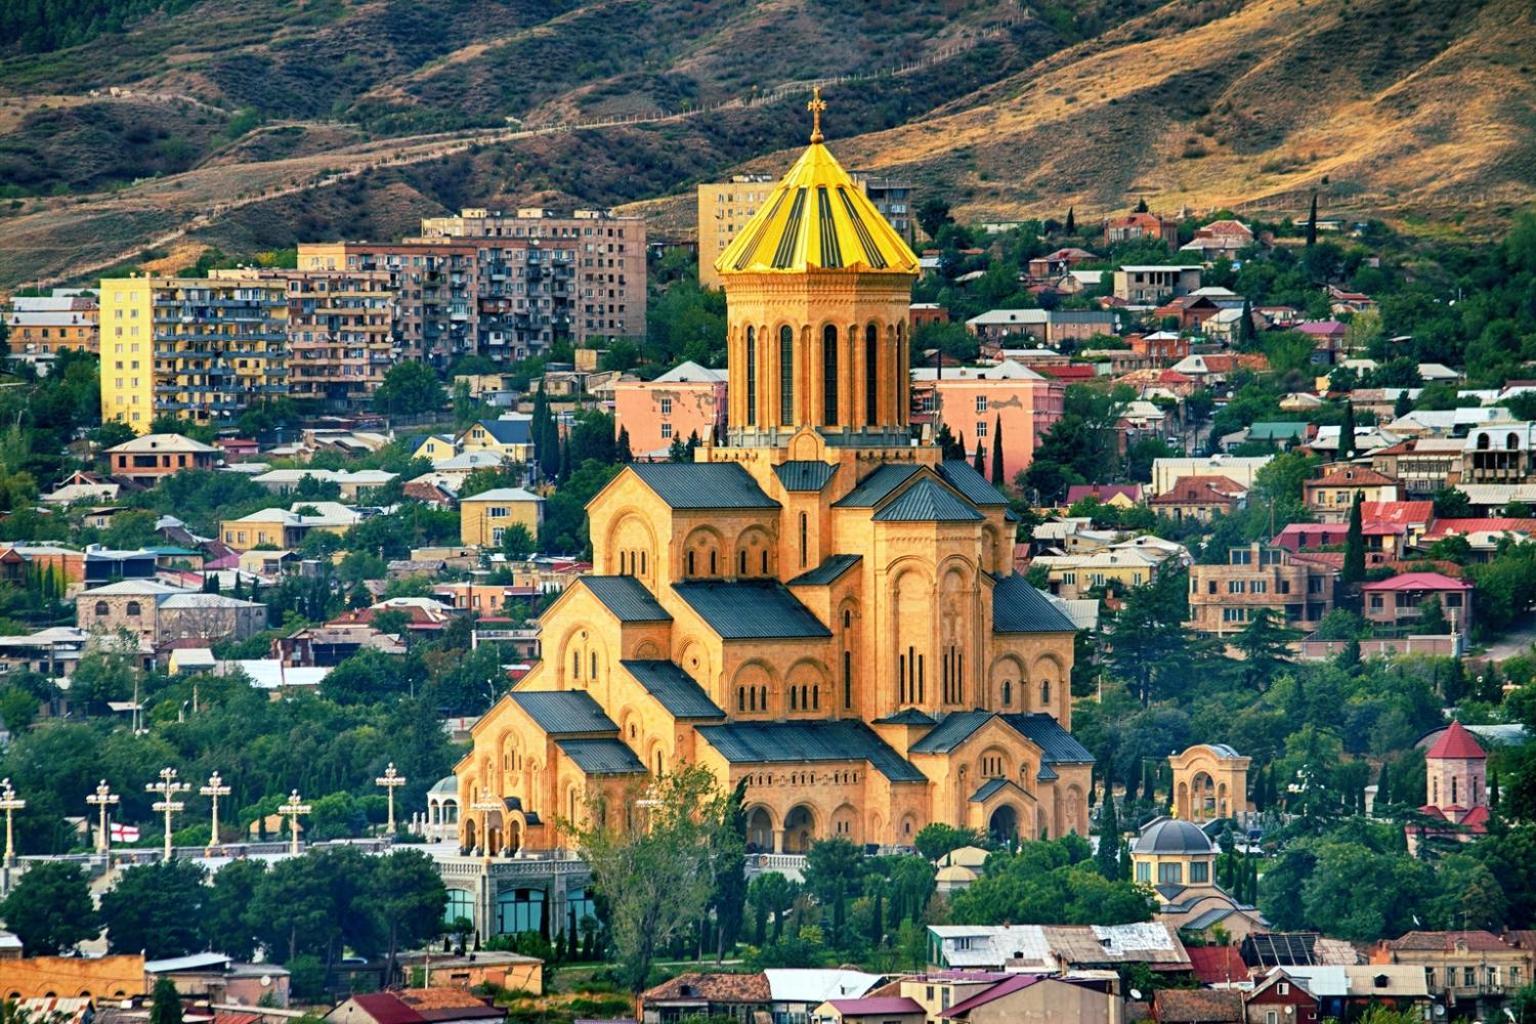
[1189,543,1338,636]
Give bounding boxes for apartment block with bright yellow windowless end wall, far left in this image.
[100,276,287,433]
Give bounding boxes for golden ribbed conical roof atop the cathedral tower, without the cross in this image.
[714,143,917,276]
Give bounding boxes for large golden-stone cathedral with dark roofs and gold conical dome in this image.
[455,98,1092,855]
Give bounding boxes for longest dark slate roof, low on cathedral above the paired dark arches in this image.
[697,720,928,783]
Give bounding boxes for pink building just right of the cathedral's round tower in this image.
[912,359,1066,485]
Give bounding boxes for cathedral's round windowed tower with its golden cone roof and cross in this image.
[714,89,919,450]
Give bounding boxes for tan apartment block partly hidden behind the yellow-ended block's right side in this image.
[214,269,395,410]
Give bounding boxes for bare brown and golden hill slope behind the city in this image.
[0,0,1536,287]
